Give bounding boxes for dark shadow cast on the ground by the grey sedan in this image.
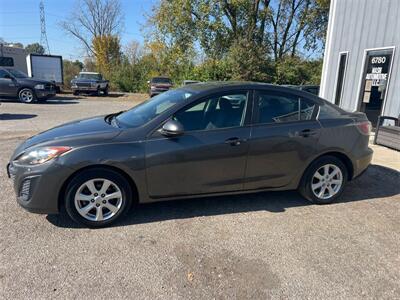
[47,165,400,228]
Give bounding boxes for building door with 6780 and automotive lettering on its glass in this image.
[359,49,393,126]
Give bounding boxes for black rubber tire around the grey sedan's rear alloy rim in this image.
[299,155,348,204]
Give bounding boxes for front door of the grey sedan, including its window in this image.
[146,91,250,198]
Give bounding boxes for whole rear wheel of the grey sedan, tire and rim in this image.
[299,156,348,204]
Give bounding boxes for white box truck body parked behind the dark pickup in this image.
[26,54,64,91]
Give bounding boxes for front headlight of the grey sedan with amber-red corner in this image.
[17,146,72,165]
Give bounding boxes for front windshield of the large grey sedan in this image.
[117,90,193,127]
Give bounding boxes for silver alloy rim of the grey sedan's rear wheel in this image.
[311,164,343,200]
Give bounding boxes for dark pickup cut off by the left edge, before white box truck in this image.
[0,67,56,103]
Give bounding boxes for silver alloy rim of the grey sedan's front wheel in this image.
[74,178,123,221]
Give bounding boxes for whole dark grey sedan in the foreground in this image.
[7,82,372,227]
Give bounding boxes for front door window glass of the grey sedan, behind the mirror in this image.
[173,92,247,131]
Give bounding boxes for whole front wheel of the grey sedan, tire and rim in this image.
[65,168,132,227]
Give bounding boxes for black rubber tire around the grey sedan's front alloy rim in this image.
[65,168,133,228]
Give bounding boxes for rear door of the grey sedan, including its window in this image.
[244,90,321,190]
